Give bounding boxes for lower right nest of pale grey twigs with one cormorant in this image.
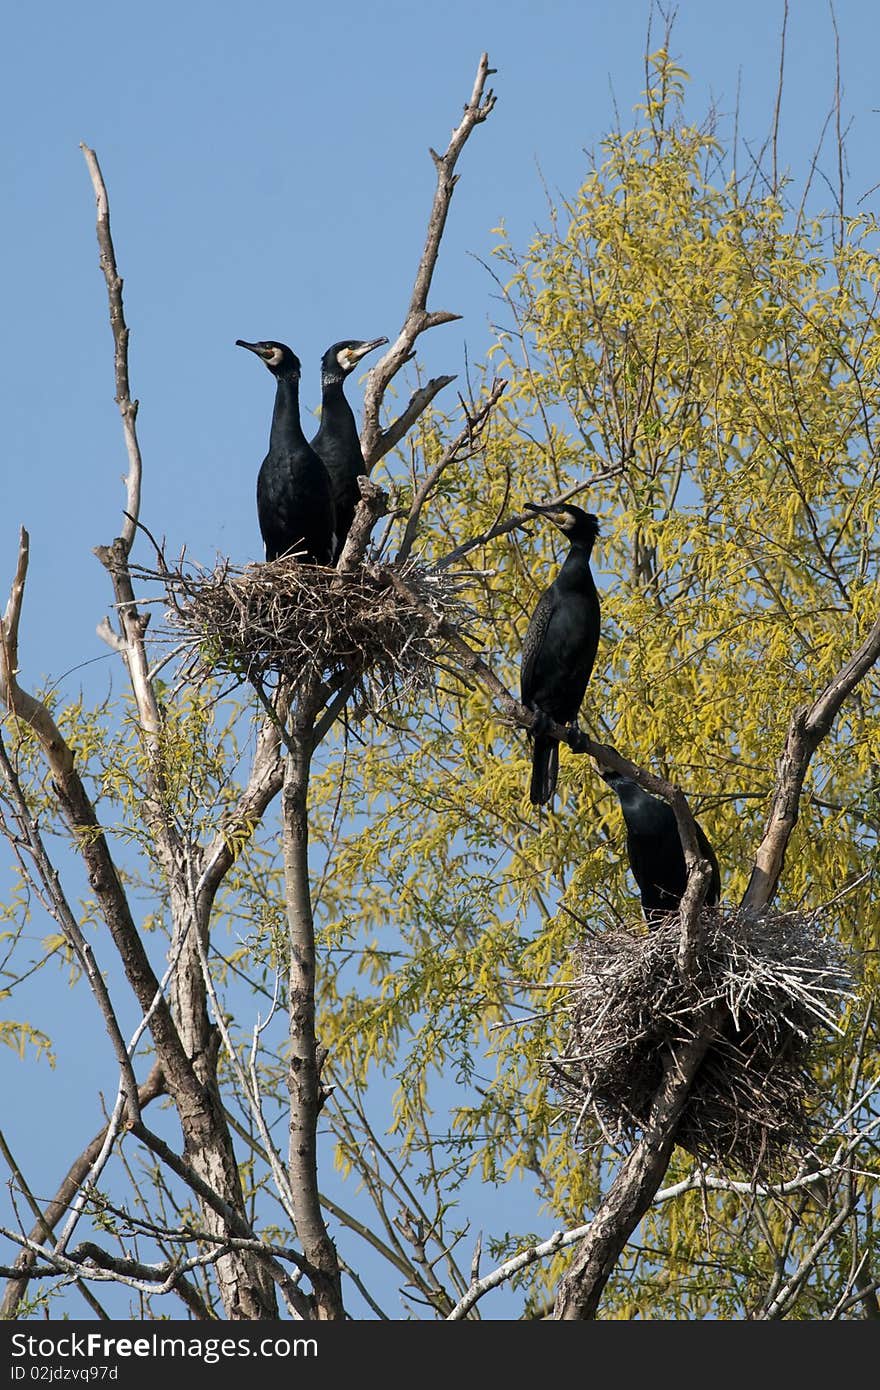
[548,909,854,1182]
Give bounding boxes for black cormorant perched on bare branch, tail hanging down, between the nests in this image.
[520,502,599,806]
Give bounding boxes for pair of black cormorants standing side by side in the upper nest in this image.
[236,338,388,564]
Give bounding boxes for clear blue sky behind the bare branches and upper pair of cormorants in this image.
[0,0,880,1315]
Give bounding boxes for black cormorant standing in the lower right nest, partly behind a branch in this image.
[599,771,722,926]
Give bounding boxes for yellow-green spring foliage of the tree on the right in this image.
[303,53,880,1316]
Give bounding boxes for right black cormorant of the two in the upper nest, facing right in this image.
[311,338,388,562]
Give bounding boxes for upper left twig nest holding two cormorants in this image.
[140,557,473,708]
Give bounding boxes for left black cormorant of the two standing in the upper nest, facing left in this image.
[235,338,336,564]
